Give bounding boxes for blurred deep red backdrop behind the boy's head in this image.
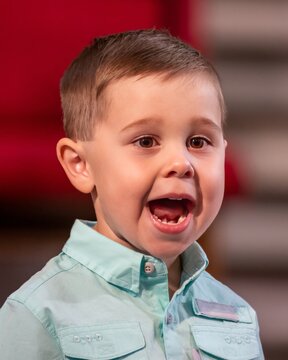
[0,0,239,202]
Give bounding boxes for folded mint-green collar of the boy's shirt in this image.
[63,220,208,294]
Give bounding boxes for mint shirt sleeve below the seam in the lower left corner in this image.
[0,300,64,360]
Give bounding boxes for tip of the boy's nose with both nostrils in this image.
[164,154,194,178]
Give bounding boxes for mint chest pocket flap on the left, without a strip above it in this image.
[58,321,146,360]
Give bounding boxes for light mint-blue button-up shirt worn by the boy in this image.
[0,220,264,360]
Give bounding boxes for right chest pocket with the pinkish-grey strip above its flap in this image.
[190,299,261,360]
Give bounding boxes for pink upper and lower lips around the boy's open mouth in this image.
[148,193,195,234]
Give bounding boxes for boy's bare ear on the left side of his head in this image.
[56,138,94,194]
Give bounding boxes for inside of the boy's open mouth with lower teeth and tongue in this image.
[149,198,193,225]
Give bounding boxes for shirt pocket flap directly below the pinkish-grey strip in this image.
[191,325,259,360]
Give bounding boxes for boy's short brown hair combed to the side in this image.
[61,29,225,141]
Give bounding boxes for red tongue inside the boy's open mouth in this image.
[149,199,185,221]
